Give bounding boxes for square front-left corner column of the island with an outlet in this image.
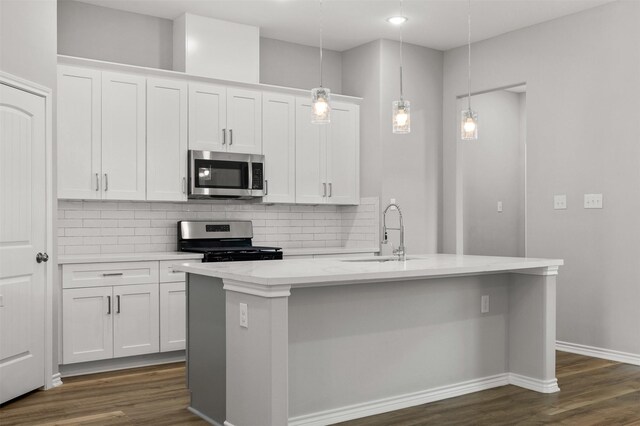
[225,290,289,426]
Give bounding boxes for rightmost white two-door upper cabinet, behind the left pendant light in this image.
[296,98,360,204]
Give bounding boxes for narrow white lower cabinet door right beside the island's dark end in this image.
[160,281,187,352]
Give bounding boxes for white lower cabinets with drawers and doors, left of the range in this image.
[61,259,199,364]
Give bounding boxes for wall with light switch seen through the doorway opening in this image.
[457,90,526,256]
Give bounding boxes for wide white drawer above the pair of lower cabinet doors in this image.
[62,262,158,288]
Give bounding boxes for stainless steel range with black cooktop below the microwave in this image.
[178,220,282,262]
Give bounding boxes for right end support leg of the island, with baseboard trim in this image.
[509,268,560,393]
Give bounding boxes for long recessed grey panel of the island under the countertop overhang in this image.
[289,274,509,418]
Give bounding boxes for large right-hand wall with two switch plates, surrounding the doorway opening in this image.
[443,1,640,356]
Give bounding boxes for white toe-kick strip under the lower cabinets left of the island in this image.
[60,351,185,377]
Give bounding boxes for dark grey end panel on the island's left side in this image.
[187,274,226,425]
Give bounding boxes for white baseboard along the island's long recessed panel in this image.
[288,373,510,426]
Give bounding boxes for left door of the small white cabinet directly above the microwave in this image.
[189,84,227,151]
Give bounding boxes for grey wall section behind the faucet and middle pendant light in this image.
[342,40,443,254]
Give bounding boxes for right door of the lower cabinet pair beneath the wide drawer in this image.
[113,284,160,357]
